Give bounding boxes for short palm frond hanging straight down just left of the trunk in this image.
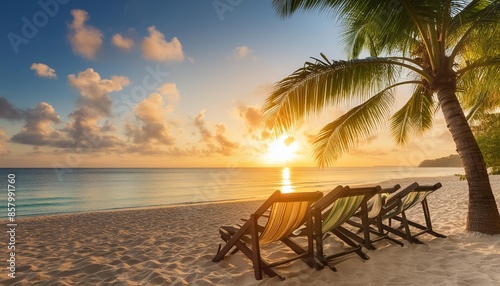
[390,84,435,145]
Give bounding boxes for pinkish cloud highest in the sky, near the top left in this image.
[69,9,103,60]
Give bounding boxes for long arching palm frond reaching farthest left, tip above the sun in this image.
[262,58,400,134]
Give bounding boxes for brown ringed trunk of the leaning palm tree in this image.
[434,80,500,234]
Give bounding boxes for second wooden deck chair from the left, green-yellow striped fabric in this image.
[312,186,381,271]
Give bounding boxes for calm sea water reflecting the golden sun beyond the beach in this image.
[0,167,463,217]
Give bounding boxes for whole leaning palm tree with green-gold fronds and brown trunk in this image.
[263,0,500,234]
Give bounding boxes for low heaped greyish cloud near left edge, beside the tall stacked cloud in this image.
[10,102,65,146]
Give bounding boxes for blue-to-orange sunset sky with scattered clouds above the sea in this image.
[0,0,455,168]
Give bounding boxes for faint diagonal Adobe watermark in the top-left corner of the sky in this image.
[7,0,70,54]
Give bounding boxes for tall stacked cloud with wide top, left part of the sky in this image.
[65,68,129,149]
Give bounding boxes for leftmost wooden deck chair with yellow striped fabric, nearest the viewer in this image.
[212,191,323,280]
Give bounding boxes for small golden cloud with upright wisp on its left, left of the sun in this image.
[194,110,239,156]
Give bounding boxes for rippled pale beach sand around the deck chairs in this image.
[0,176,500,286]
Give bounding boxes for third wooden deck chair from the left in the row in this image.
[343,184,404,250]
